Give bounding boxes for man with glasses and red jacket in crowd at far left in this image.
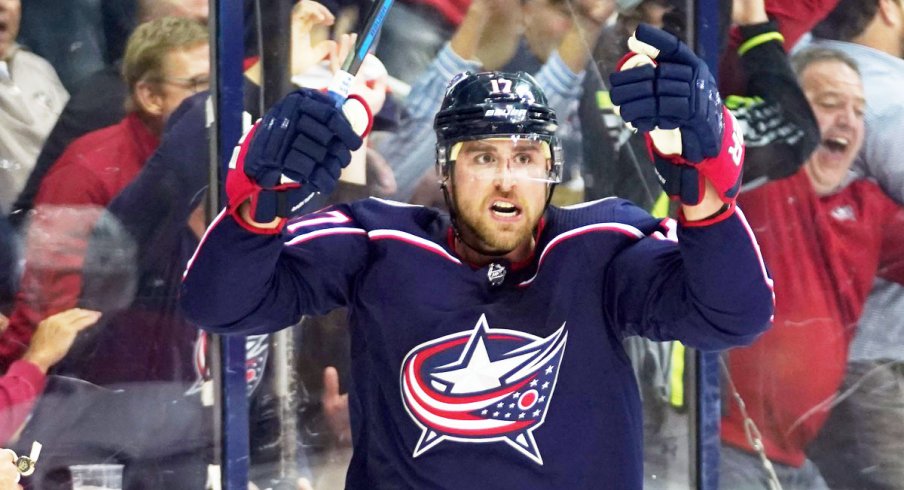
[0,17,210,369]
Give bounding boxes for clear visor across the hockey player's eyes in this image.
[437,134,562,184]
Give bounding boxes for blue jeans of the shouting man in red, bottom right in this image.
[719,444,829,490]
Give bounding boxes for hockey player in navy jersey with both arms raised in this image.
[182,26,772,489]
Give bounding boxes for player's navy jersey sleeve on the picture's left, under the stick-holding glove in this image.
[180,206,367,334]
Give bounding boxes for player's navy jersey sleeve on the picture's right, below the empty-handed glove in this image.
[603,201,774,350]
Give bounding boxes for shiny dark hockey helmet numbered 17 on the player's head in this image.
[433,71,562,184]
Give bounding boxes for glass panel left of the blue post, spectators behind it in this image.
[0,0,217,489]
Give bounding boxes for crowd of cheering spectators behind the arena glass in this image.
[0,0,904,489]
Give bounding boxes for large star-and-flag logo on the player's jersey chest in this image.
[401,315,568,465]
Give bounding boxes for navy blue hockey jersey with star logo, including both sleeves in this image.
[182,199,773,489]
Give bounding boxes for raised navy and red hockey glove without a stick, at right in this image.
[609,24,744,205]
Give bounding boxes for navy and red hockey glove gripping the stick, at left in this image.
[226,89,370,233]
